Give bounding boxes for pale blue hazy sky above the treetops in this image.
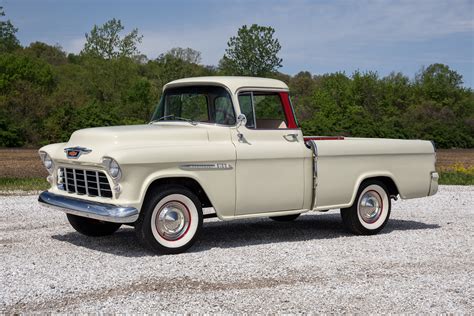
[0,0,474,87]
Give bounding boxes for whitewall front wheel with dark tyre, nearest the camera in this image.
[135,186,203,254]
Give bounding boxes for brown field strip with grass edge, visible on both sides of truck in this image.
[0,149,474,191]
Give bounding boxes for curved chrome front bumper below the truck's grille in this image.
[38,191,138,223]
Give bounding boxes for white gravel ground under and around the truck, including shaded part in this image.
[0,186,474,314]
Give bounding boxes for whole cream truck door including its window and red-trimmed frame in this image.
[232,91,305,215]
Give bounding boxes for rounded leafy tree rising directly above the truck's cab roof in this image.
[219,24,282,76]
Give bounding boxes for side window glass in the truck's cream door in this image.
[239,92,288,129]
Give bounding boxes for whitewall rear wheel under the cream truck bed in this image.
[341,180,391,235]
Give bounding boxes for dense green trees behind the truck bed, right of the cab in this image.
[289,64,474,148]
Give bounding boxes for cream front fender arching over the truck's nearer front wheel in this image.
[107,141,236,216]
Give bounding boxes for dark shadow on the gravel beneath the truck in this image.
[52,214,440,257]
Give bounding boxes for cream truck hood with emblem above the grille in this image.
[40,122,209,164]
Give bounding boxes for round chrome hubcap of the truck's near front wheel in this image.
[155,201,190,240]
